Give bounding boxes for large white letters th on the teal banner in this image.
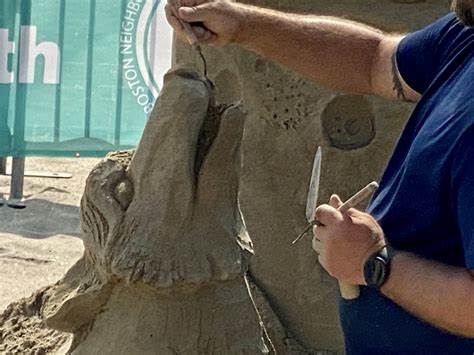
[0,26,61,84]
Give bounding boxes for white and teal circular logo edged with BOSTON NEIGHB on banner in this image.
[120,0,171,114]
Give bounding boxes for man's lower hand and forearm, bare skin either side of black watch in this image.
[313,196,474,338]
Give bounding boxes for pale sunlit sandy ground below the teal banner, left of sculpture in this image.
[0,158,99,313]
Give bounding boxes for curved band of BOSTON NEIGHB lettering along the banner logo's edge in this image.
[119,0,157,114]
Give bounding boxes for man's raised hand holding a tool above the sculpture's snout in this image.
[165,0,246,46]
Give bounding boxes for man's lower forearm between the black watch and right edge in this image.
[381,253,474,337]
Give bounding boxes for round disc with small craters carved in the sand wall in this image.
[321,95,375,150]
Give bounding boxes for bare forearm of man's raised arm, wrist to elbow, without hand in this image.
[236,5,384,93]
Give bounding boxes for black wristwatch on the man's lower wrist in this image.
[364,245,396,290]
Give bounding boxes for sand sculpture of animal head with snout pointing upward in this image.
[39,69,280,354]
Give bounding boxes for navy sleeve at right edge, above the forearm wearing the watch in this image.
[451,126,474,269]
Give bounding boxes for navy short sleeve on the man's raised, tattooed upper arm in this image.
[396,13,465,94]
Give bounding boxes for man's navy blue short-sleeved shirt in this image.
[340,14,474,355]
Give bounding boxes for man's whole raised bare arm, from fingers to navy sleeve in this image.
[167,0,419,101]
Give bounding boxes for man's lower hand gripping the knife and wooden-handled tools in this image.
[313,195,386,285]
